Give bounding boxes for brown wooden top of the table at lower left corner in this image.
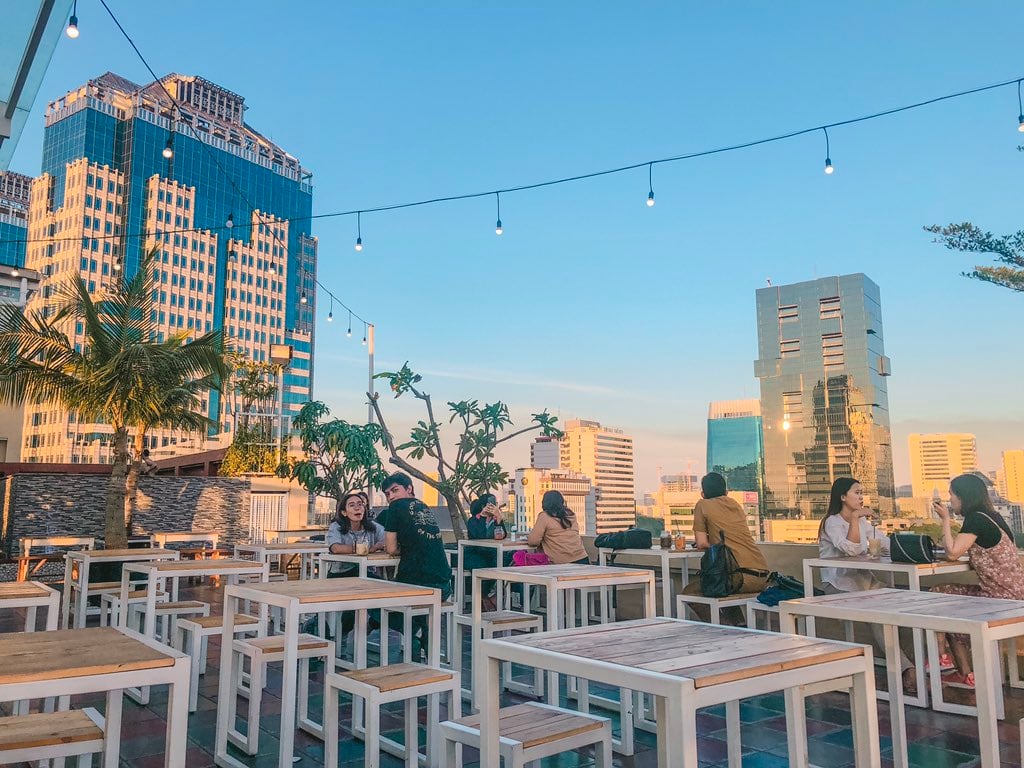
[0,627,174,685]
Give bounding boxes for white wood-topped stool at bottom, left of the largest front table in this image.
[324,664,462,768]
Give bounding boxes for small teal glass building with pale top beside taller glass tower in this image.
[708,399,764,494]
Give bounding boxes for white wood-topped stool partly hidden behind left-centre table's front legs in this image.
[227,634,334,755]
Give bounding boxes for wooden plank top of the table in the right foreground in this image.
[786,589,1024,627]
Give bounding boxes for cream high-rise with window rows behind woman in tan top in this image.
[559,420,636,534]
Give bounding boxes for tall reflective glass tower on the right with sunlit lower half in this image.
[755,274,895,517]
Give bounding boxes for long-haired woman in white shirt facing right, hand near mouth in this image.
[818,477,918,693]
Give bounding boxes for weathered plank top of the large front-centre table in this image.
[502,618,864,688]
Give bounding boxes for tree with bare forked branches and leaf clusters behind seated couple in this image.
[368,362,562,539]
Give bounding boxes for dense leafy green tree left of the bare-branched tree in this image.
[278,400,386,518]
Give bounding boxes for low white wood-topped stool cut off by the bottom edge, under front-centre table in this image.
[441,702,611,768]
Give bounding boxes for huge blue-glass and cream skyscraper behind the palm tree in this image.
[24,73,316,463]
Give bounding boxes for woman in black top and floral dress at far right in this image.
[932,474,1024,688]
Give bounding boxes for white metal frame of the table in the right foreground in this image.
[778,590,1024,768]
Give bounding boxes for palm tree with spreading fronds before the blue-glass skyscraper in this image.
[0,249,227,548]
